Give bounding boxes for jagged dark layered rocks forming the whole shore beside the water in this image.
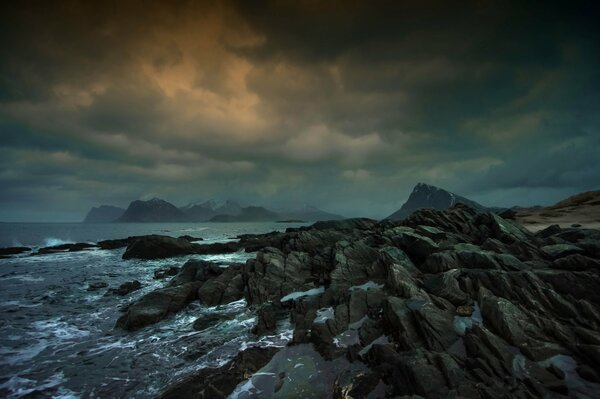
[2,204,600,398]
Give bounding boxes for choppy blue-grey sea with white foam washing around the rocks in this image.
[0,223,297,398]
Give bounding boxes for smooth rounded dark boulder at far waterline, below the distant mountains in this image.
[123,235,196,259]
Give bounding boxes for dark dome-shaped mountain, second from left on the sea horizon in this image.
[116,198,187,223]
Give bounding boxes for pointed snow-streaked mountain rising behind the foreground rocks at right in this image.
[386,183,487,220]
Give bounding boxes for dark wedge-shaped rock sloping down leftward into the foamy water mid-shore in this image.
[116,283,198,331]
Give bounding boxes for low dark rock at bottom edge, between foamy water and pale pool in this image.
[159,347,278,399]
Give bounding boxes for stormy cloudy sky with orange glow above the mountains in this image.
[0,0,600,221]
